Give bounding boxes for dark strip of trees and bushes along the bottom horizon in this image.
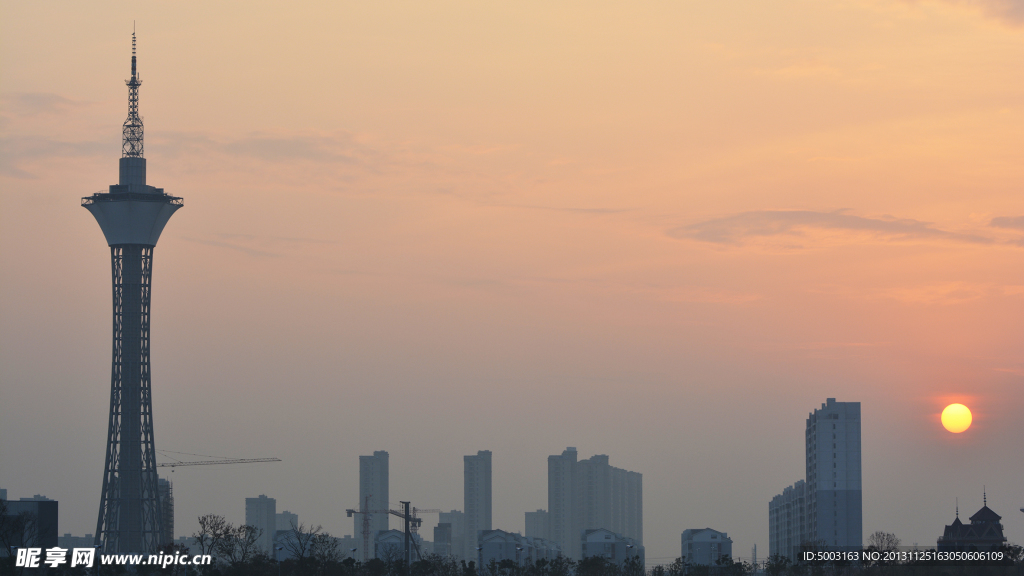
[0,515,1024,576]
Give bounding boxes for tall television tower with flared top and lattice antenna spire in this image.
[82,32,183,553]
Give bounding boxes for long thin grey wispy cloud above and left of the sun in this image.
[668,210,992,248]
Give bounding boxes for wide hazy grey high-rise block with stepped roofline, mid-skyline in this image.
[547,447,643,560]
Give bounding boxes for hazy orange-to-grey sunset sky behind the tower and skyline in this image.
[0,0,1024,563]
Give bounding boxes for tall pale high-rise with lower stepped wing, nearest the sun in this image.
[768,398,863,558]
